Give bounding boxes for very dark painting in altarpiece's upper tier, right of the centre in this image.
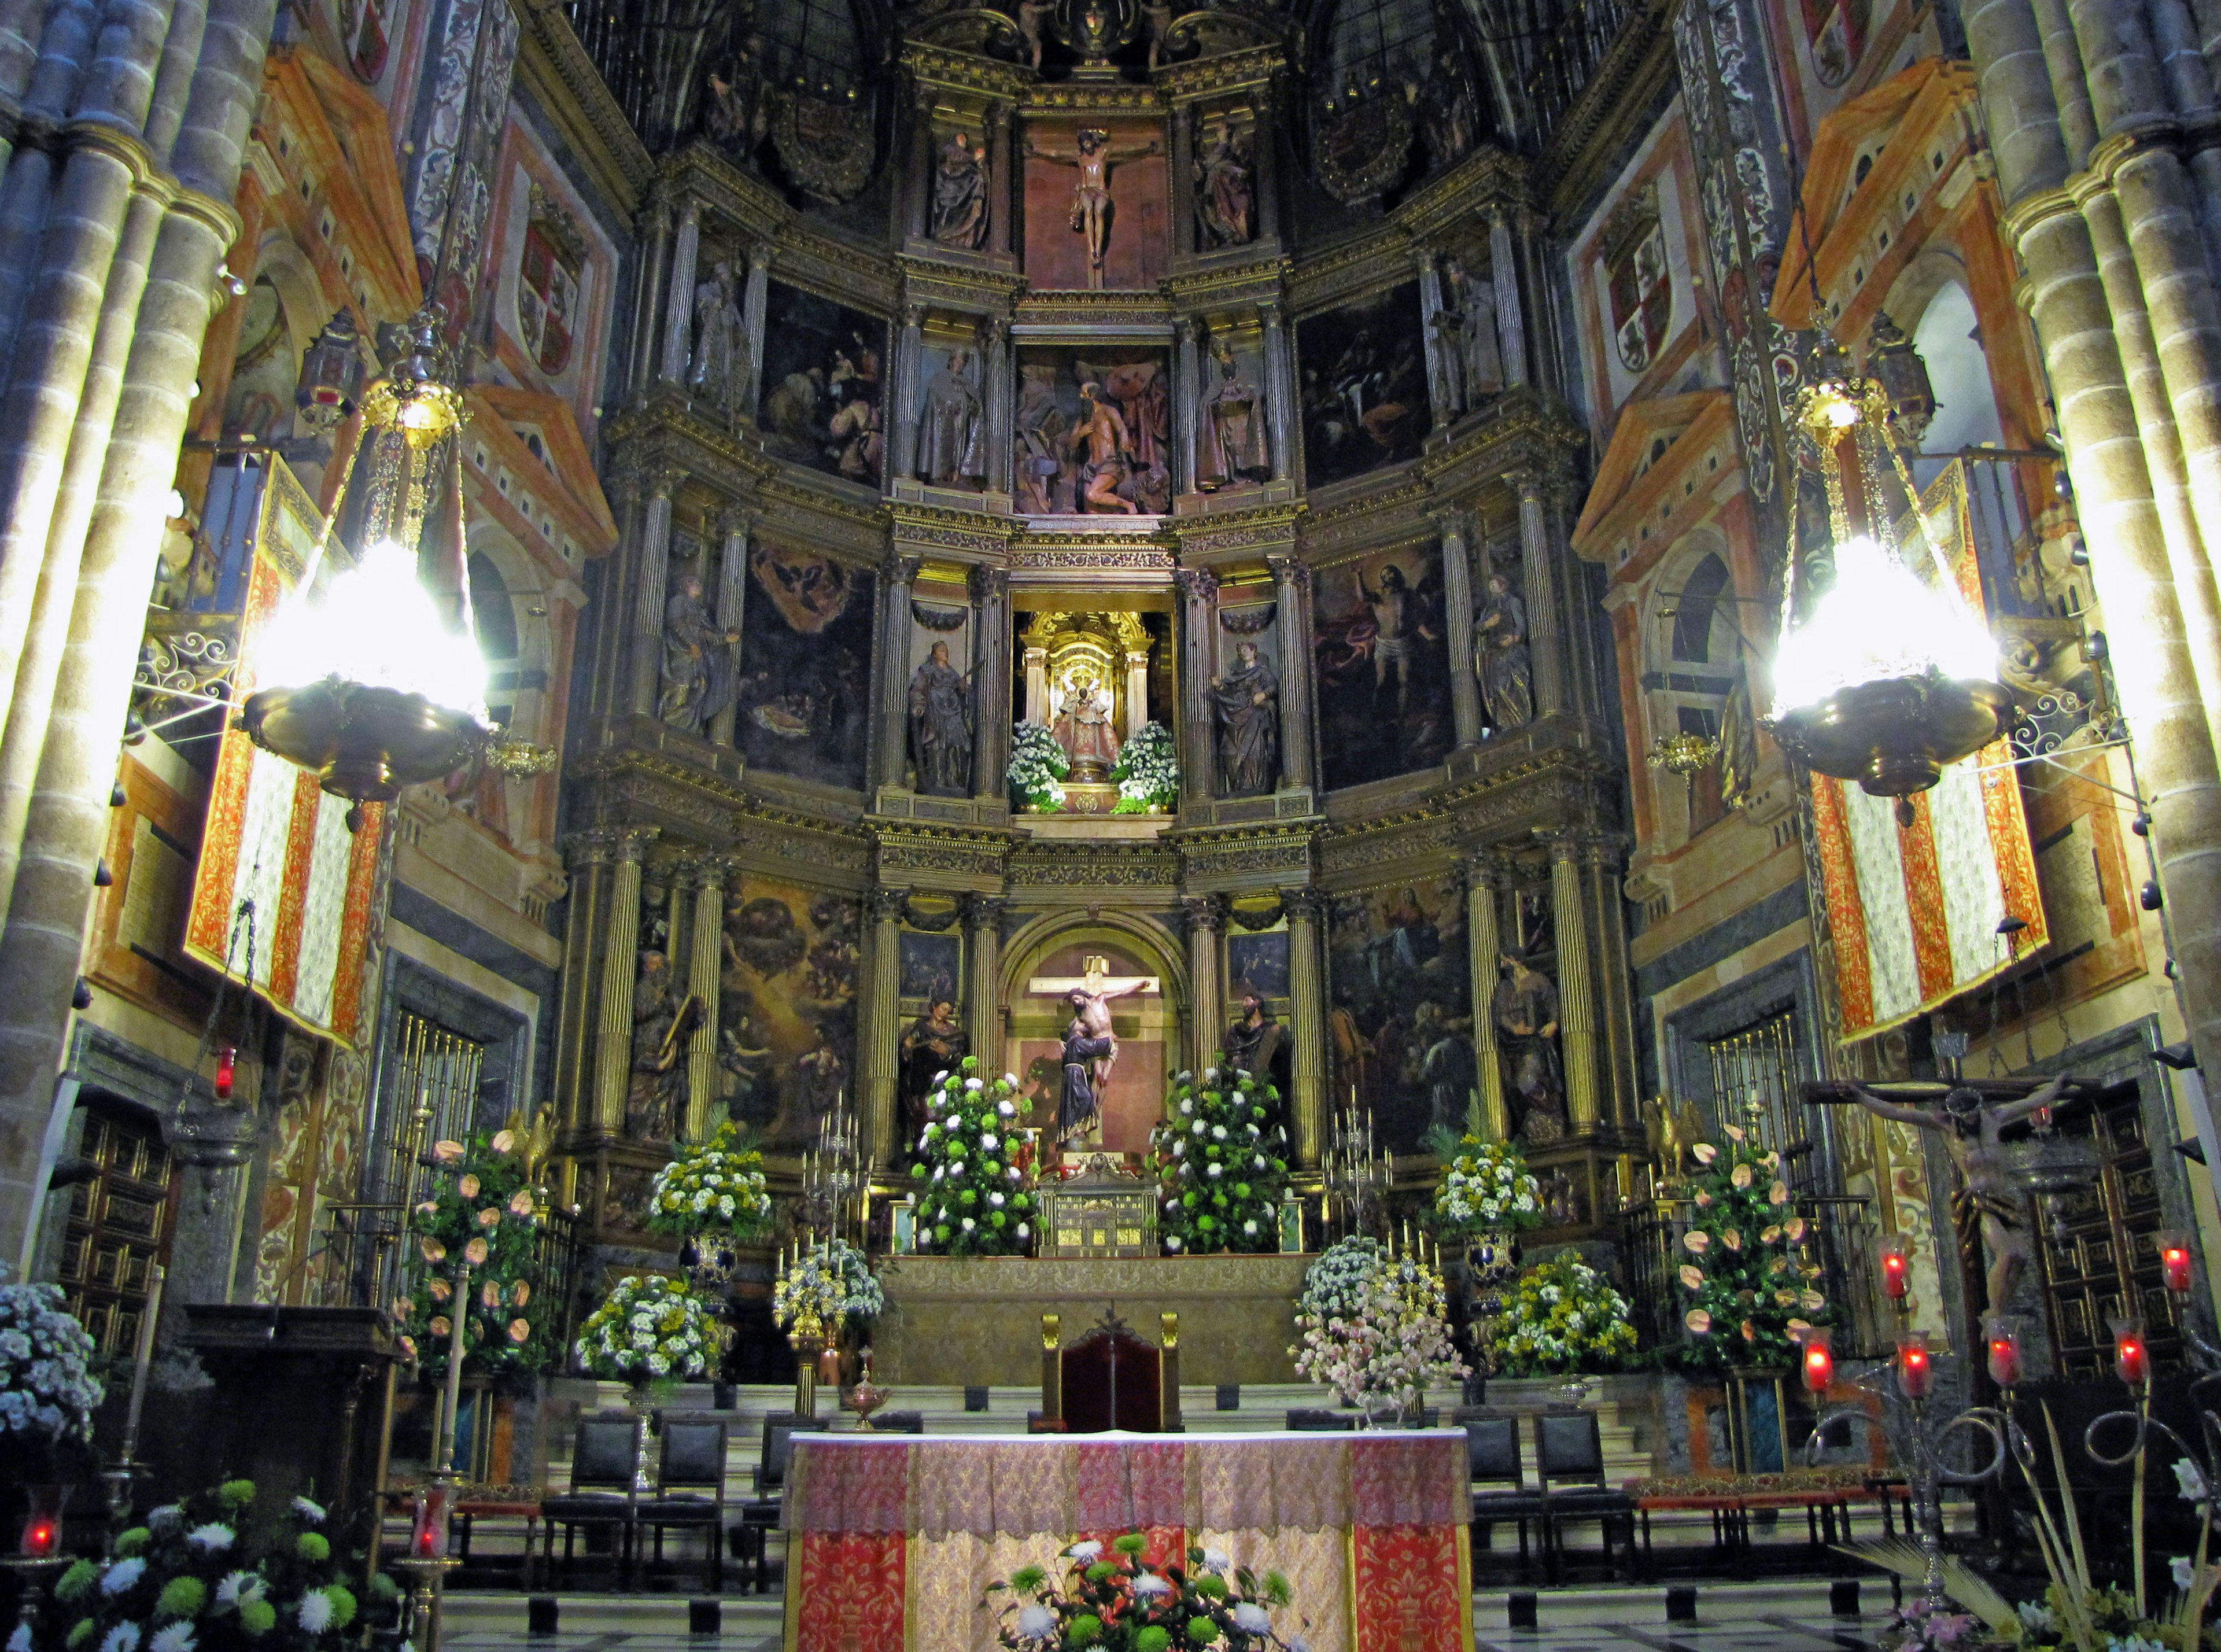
[1295,282,1435,489]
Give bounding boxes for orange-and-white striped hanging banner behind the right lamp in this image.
[1812,462,2050,1043]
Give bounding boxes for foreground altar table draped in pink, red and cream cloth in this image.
[782,1430,1473,1652]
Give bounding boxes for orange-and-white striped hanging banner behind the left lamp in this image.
[185,453,384,1043]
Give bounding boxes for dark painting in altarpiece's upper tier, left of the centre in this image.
[755,282,886,489]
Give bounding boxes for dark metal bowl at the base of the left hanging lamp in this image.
[240,677,489,804]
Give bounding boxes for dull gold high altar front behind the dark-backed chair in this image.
[873,1257,1311,1388]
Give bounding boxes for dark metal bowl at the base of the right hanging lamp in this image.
[1768,675,2012,797]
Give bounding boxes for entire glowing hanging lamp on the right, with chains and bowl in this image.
[1766,373,2012,826]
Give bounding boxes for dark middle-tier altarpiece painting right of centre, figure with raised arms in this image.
[1312,546,1455,791]
